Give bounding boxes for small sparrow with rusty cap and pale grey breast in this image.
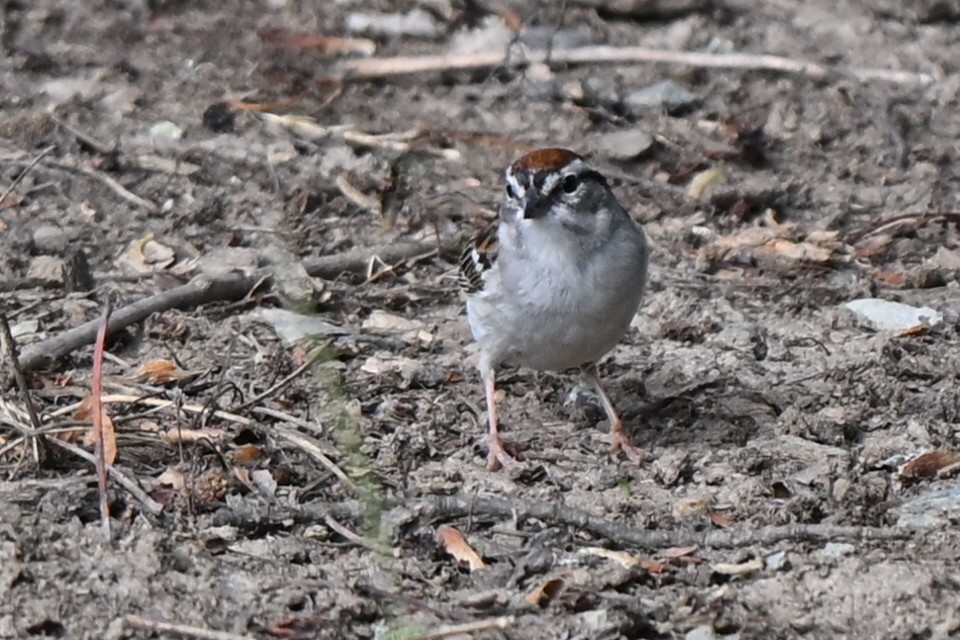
[459,148,649,470]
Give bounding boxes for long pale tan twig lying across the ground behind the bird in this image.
[339,45,933,85]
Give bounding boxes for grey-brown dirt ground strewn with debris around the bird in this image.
[0,0,960,640]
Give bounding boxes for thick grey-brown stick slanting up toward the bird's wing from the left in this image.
[20,242,446,372]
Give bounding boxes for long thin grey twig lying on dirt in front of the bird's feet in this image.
[411,496,913,549]
